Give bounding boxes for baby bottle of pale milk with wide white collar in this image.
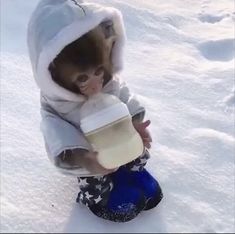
[80,93,144,169]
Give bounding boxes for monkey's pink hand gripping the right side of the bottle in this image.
[132,120,152,149]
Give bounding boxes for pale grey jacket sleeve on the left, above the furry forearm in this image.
[41,98,91,162]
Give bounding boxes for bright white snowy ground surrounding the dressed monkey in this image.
[1,0,235,233]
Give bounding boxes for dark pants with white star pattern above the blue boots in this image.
[77,150,150,206]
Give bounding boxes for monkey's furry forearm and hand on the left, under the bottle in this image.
[59,149,117,175]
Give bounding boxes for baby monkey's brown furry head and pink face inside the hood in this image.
[49,20,116,96]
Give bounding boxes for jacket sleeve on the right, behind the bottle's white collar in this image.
[119,82,145,120]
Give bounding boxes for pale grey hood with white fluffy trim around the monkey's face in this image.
[28,0,125,101]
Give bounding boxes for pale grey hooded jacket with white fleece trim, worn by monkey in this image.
[28,0,144,176]
